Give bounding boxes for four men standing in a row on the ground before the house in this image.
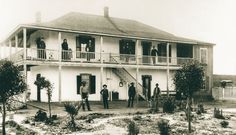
[80,81,161,112]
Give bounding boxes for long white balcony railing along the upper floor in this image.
[5,48,193,65]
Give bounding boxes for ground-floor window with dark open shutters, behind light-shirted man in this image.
[77,74,96,94]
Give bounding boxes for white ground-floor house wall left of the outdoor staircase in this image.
[27,66,131,101]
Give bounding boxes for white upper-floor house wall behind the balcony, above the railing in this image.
[29,30,176,58]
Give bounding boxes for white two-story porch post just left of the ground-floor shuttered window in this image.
[58,32,62,103]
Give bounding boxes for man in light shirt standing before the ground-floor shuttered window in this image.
[80,82,92,111]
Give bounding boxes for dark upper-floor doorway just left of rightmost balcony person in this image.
[142,41,152,64]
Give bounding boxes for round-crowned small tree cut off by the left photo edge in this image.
[0,61,27,135]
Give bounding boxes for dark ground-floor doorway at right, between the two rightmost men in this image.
[142,75,152,100]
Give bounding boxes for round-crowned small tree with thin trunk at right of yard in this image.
[173,61,204,132]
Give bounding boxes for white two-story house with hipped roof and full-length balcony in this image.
[1,8,213,101]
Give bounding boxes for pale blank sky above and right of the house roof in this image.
[0,0,236,75]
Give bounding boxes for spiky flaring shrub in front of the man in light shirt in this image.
[64,102,81,131]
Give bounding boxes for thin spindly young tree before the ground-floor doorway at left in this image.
[34,76,53,119]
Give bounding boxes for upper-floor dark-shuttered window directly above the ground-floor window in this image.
[76,36,95,59]
